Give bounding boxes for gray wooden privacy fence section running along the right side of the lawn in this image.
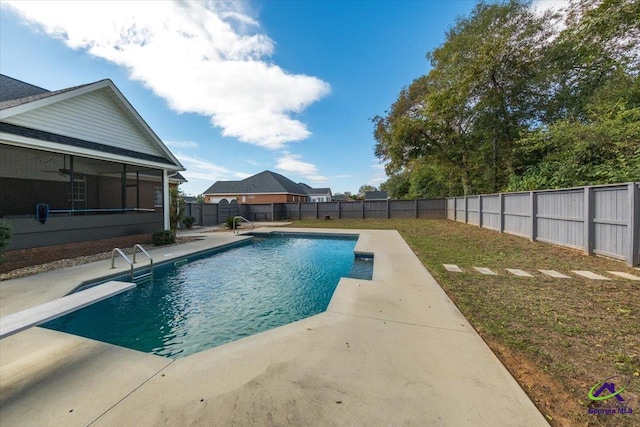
[447,183,640,266]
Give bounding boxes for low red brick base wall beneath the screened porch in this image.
[0,233,151,273]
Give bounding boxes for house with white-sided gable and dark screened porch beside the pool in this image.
[0,74,185,270]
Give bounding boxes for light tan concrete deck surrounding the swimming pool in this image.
[0,228,548,426]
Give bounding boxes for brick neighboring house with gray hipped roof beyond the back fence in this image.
[202,170,331,204]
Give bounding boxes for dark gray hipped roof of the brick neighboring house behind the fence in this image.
[203,171,307,195]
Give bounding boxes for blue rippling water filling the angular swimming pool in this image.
[43,236,372,358]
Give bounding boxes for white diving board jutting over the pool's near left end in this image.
[0,281,136,339]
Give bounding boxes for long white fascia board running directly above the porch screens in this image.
[0,132,185,172]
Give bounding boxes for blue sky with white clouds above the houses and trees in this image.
[0,0,554,195]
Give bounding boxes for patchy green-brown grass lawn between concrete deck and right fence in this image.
[293,220,640,426]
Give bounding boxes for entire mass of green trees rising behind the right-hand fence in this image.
[373,0,640,198]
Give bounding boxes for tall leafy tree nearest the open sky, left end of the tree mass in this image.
[373,1,550,196]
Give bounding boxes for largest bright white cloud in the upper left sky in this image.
[3,1,330,149]
